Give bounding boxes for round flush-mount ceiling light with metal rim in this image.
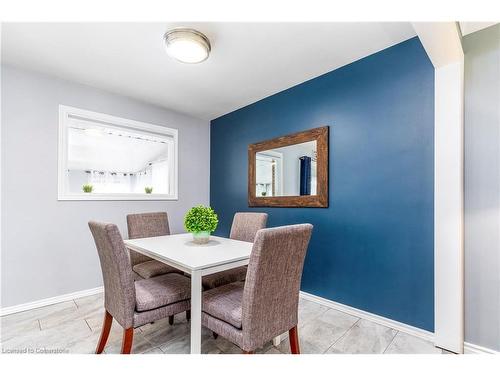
[163,28,210,64]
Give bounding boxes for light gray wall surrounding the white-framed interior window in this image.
[1,66,209,307]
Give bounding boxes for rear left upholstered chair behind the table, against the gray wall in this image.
[127,212,182,279]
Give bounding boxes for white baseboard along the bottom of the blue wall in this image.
[300,291,434,342]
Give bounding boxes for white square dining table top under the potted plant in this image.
[124,233,253,271]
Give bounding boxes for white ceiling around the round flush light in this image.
[2,22,415,120]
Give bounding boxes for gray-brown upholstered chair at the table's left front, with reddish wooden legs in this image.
[89,221,191,354]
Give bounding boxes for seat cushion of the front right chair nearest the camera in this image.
[202,281,245,329]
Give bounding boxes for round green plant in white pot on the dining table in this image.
[184,205,219,244]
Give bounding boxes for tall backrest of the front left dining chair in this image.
[89,221,136,328]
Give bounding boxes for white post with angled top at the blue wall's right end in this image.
[413,22,464,353]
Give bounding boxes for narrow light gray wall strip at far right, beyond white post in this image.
[464,25,500,351]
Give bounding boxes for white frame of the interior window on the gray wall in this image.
[57,104,179,201]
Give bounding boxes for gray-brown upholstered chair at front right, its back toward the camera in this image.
[202,224,312,354]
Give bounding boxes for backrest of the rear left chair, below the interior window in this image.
[127,212,170,267]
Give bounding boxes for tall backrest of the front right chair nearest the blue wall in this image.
[242,224,313,349]
